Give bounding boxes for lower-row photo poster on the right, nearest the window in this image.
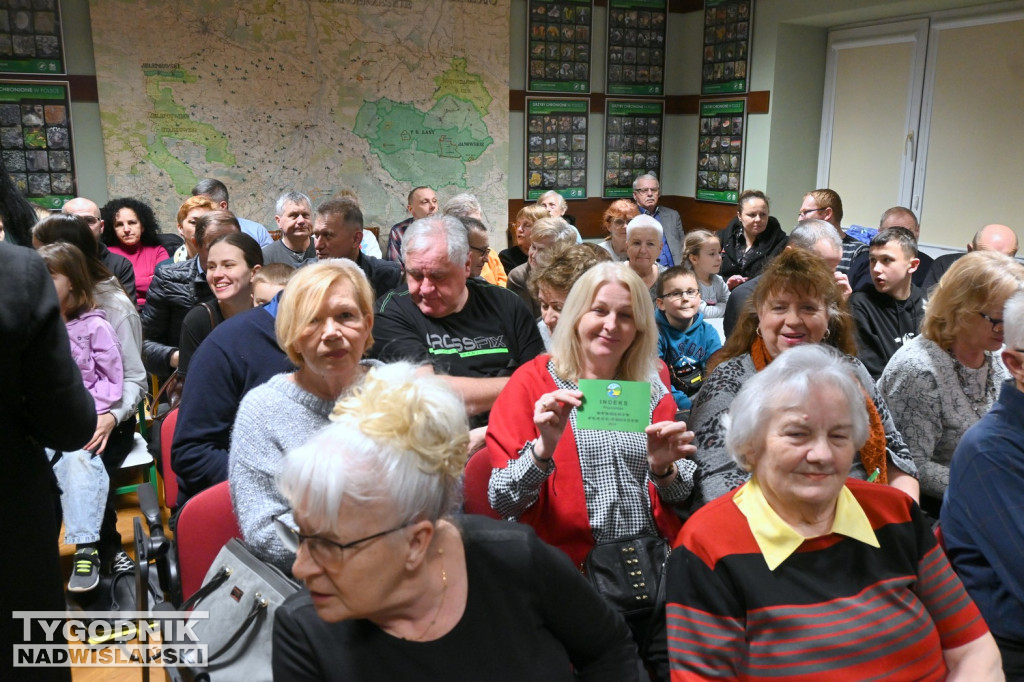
[695,99,746,204]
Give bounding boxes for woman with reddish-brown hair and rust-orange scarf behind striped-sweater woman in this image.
[690,249,919,508]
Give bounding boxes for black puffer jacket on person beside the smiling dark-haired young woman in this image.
[139,258,214,381]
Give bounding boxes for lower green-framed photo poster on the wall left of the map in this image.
[0,81,76,209]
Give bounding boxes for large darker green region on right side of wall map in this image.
[352,94,494,187]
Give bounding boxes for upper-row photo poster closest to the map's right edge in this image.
[526,0,594,92]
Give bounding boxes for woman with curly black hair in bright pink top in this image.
[100,198,171,307]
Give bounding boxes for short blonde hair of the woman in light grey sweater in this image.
[273,258,374,368]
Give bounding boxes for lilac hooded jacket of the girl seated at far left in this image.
[66,308,124,415]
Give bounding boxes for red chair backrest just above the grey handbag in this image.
[174,480,242,598]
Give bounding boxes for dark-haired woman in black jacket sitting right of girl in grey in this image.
[718,189,786,291]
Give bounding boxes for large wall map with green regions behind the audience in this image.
[81,0,509,230]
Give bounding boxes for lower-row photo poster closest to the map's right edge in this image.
[525,97,590,201]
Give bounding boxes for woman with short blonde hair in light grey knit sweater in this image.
[228,259,378,572]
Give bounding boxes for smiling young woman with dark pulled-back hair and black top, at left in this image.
[178,232,263,380]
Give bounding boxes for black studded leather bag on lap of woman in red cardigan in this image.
[583,536,672,619]
